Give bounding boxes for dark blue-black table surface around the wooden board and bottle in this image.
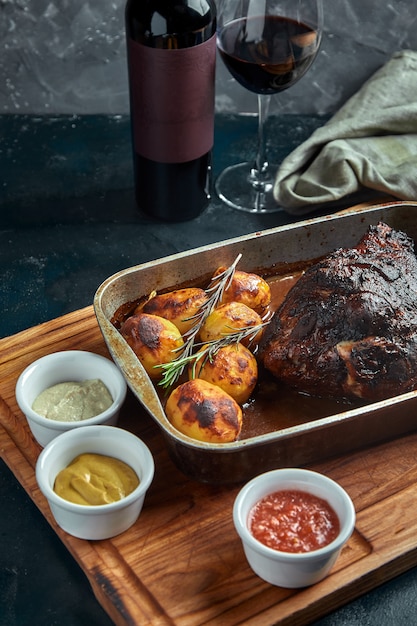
[0,115,417,626]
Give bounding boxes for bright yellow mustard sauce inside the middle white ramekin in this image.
[54,453,139,505]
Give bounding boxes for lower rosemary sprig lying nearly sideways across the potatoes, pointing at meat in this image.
[155,321,269,389]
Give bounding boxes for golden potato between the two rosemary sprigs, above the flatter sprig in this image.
[199,302,262,346]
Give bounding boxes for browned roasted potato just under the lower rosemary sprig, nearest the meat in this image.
[188,343,258,404]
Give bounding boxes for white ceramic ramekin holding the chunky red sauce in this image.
[233,468,356,588]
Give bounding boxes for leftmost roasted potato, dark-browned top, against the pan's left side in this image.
[120,313,184,380]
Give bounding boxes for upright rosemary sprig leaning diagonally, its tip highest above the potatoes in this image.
[155,254,242,389]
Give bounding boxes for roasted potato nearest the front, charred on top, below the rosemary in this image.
[165,378,242,443]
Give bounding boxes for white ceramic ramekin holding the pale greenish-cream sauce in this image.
[16,350,127,446]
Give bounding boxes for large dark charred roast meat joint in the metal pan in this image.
[259,223,417,401]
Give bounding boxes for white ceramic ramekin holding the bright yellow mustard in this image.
[36,426,155,539]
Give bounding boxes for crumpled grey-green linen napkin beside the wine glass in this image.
[274,50,417,215]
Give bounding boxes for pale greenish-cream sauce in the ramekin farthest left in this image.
[32,379,113,422]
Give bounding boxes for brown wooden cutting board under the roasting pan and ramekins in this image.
[0,307,417,626]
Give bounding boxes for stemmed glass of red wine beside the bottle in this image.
[216,0,323,213]
